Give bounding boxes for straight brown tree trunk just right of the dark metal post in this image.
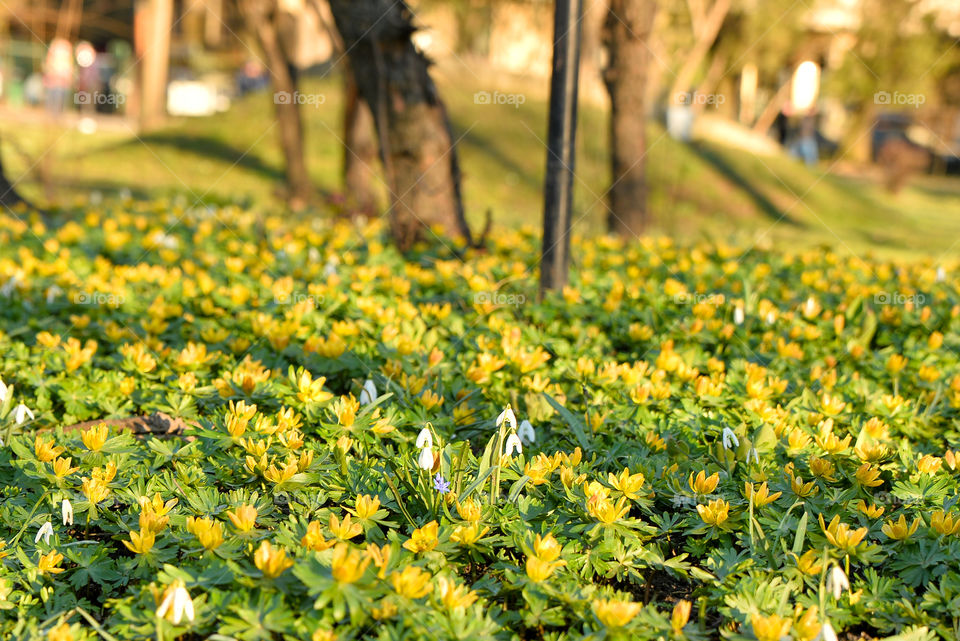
[604,0,657,238]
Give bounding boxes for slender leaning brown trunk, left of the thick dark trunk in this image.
[239,0,313,209]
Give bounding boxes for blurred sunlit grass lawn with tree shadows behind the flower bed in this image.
[2,69,960,260]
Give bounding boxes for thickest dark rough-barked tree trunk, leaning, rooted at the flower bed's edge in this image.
[330,0,472,249]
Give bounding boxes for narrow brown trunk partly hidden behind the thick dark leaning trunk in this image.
[343,67,377,216]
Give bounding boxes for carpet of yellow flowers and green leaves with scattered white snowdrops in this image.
[0,200,960,641]
